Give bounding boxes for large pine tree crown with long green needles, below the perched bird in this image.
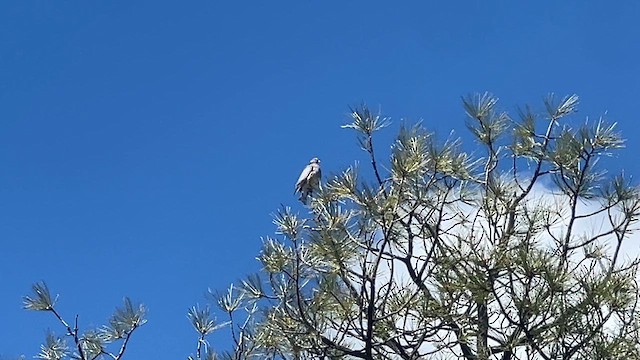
[192,93,640,360]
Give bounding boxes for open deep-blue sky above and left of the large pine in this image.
[0,0,640,359]
